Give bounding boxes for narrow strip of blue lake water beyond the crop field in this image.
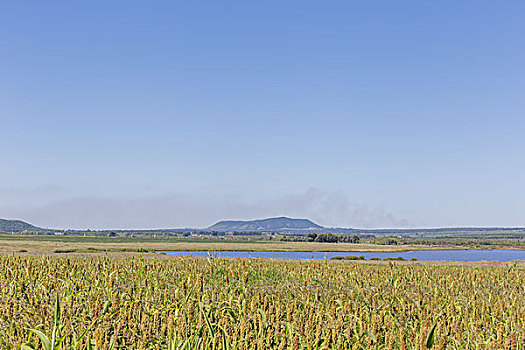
[156,249,525,261]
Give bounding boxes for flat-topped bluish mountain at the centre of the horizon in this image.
[208,217,324,232]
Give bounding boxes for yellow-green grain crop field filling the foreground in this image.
[0,256,525,350]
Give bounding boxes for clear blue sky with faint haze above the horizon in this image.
[0,0,525,229]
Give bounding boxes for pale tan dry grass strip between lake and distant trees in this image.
[0,235,510,254]
